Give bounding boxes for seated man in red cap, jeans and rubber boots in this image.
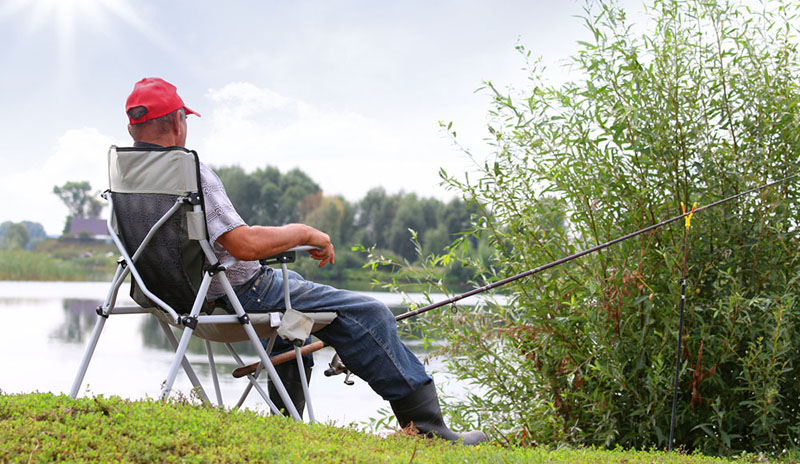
[125,78,486,444]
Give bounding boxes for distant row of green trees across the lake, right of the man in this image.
[215,166,484,274]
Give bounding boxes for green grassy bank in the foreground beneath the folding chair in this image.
[0,393,780,464]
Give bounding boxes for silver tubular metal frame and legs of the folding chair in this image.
[70,146,336,422]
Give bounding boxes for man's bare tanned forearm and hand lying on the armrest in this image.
[217,224,334,267]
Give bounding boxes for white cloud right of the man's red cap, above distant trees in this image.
[197,82,462,200]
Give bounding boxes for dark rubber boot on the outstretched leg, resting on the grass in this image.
[389,381,486,445]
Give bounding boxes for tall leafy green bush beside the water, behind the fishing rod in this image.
[390,0,800,454]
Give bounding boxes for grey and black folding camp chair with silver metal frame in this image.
[65,146,336,422]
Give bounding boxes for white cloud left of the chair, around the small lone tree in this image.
[0,128,113,235]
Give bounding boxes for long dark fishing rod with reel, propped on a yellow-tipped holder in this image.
[233,172,800,378]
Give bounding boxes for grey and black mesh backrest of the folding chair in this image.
[108,146,208,314]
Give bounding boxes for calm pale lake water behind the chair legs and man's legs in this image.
[0,282,482,425]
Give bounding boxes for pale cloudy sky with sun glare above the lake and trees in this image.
[0,0,642,235]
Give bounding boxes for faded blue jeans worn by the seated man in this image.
[231,266,431,401]
